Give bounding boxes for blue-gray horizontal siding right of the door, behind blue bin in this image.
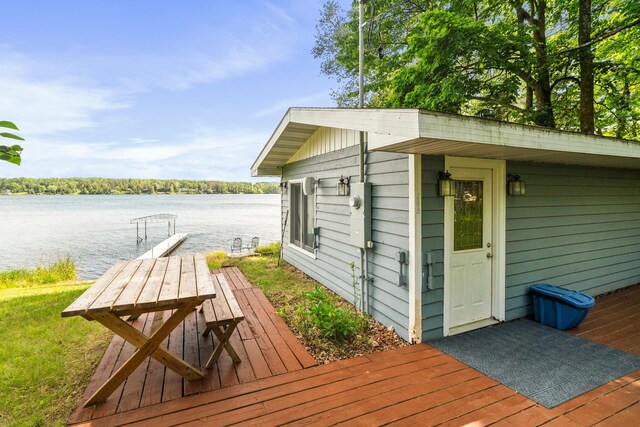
[506,162,640,319]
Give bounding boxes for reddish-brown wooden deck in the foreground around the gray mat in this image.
[67,285,640,427]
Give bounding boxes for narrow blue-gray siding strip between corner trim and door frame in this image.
[422,156,444,340]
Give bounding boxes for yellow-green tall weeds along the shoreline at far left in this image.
[0,257,76,289]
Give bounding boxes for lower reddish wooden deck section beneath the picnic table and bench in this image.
[68,268,317,423]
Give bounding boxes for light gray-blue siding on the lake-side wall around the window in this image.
[282,146,409,339]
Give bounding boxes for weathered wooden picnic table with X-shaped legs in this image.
[62,254,216,407]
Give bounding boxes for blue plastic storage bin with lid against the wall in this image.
[529,284,596,331]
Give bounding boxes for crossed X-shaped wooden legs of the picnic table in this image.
[84,302,205,407]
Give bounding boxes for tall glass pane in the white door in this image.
[453,180,482,251]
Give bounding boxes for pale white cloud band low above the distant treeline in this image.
[0,127,268,181]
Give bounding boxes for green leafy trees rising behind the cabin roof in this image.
[313,0,640,138]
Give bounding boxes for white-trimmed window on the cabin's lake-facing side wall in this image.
[289,182,315,253]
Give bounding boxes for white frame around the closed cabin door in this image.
[442,156,507,336]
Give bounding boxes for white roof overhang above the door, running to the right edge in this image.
[368,111,640,169]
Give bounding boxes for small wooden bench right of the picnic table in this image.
[200,273,244,368]
